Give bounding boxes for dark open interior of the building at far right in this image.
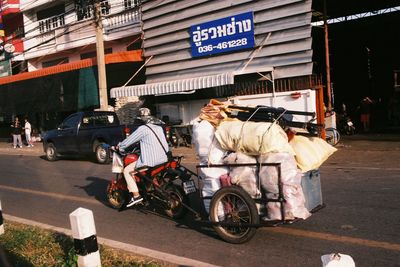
[313,11,400,130]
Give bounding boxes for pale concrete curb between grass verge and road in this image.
[3,214,218,267]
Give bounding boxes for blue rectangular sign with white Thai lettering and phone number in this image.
[190,12,254,57]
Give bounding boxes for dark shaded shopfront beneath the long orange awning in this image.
[0,62,144,138]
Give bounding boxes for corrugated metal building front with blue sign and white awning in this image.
[111,0,323,124]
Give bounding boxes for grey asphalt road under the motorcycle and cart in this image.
[0,139,400,266]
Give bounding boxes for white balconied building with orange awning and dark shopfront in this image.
[0,0,143,135]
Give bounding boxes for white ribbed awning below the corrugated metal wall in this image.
[110,72,235,98]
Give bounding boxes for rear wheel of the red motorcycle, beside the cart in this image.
[164,185,188,219]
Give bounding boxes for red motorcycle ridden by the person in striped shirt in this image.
[106,146,197,219]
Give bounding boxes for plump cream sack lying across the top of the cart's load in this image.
[215,121,295,155]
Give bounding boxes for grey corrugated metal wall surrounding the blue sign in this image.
[142,0,312,83]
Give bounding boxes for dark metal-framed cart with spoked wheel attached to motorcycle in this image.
[197,163,324,244]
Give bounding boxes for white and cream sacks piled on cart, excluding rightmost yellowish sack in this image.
[192,120,333,220]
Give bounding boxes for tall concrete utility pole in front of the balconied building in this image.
[94,0,108,110]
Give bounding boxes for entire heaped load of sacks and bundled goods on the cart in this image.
[193,100,336,220]
